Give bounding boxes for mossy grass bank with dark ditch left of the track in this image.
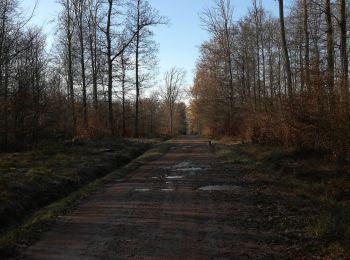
[0,139,172,258]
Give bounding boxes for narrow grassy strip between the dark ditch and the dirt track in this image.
[0,140,171,259]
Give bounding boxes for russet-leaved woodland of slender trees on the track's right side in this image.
[190,0,350,160]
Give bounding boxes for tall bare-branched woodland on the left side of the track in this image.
[0,0,186,150]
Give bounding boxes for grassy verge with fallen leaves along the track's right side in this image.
[215,140,350,259]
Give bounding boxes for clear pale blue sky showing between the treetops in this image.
[22,0,289,88]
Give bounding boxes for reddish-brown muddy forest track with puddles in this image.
[24,137,304,259]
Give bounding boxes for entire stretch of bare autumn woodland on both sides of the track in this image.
[0,0,350,161]
